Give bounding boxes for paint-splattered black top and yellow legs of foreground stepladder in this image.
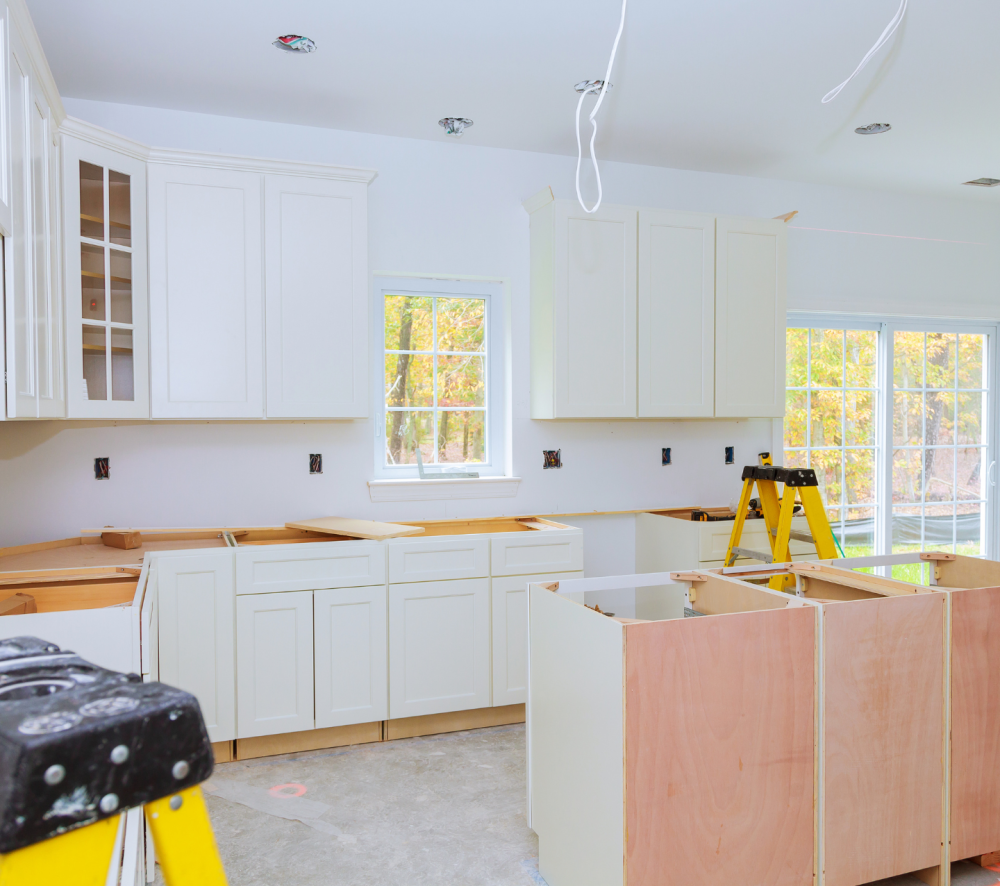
[0,637,226,886]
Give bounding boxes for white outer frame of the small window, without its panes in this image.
[372,274,509,482]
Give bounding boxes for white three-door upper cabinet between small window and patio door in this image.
[525,189,786,418]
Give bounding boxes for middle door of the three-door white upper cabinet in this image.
[637,209,715,418]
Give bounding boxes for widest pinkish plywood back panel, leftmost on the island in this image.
[625,607,816,886]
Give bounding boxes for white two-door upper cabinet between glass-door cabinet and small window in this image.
[149,151,374,418]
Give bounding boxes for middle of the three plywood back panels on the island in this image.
[823,593,946,886]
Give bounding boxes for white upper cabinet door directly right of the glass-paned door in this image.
[148,162,264,418]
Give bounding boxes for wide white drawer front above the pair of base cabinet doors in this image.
[236,541,385,594]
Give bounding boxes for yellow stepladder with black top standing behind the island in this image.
[725,452,839,591]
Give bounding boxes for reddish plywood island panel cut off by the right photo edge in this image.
[951,588,1000,860]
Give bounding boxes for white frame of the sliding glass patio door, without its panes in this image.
[782,311,1000,559]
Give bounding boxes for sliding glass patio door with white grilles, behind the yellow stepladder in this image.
[784,315,997,582]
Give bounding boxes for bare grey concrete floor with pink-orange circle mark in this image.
[156,724,1000,886]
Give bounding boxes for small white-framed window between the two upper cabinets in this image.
[376,279,503,478]
